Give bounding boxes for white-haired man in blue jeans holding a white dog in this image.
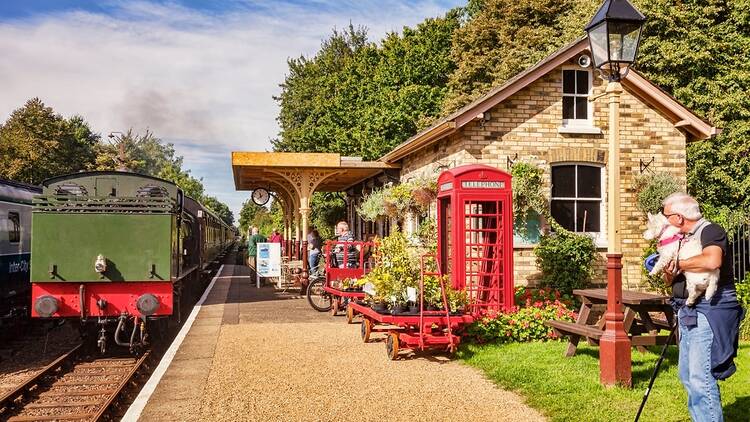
[662,193,744,422]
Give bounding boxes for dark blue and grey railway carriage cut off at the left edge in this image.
[0,179,42,324]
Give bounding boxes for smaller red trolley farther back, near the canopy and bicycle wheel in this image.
[323,240,375,323]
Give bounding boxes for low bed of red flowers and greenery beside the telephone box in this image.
[467,300,578,343]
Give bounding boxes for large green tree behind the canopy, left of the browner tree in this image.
[273,11,460,160]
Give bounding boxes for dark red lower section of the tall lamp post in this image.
[599,253,632,387]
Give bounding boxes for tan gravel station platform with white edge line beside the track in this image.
[123,265,545,421]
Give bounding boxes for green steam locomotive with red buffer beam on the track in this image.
[31,172,231,351]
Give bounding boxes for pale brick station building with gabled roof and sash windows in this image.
[348,38,718,288]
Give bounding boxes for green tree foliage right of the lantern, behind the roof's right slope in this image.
[636,0,750,209]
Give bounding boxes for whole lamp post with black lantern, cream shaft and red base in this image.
[586,0,646,387]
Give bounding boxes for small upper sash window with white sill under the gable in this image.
[559,68,601,133]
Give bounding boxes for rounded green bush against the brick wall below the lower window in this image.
[534,230,598,294]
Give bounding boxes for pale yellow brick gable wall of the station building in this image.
[401,62,686,289]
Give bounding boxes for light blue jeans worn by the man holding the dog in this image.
[679,312,724,422]
